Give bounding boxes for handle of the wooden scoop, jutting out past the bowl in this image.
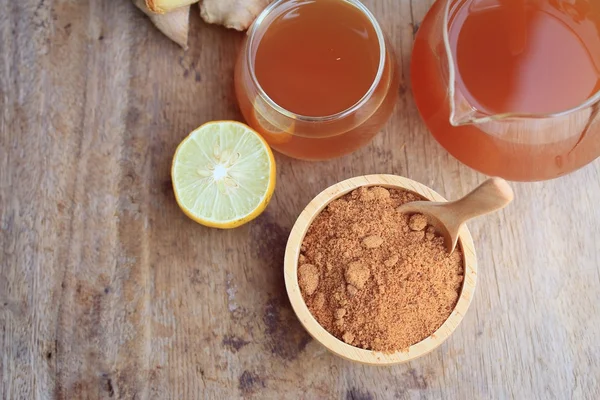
[447,177,514,224]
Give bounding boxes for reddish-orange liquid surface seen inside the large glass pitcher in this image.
[450,0,600,114]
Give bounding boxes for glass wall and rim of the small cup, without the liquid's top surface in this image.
[235,0,399,160]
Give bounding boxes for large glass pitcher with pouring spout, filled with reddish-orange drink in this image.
[411,0,600,181]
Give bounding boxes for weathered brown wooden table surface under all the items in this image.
[0,0,600,399]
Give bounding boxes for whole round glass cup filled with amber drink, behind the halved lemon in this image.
[235,0,398,160]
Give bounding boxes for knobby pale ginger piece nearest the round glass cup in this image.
[200,0,271,31]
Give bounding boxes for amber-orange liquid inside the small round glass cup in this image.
[236,0,397,160]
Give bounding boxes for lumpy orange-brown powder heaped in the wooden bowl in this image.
[298,187,464,353]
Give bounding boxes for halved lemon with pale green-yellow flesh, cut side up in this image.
[171,121,275,229]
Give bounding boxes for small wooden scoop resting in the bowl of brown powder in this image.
[398,178,514,253]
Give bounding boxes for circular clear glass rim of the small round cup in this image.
[244,0,387,122]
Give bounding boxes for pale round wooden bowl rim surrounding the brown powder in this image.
[284,175,477,365]
